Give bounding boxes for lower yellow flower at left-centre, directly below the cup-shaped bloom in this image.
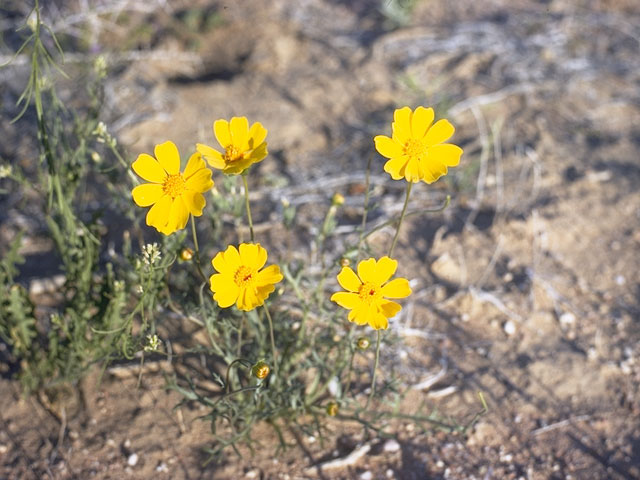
[210,243,283,311]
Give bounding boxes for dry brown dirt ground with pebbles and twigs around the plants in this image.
[0,0,640,480]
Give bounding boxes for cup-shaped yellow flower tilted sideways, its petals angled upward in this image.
[196,117,267,175]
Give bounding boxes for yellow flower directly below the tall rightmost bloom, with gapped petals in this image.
[331,256,411,330]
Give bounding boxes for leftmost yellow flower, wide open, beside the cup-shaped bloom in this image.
[131,142,213,235]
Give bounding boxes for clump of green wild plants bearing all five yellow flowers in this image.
[0,1,484,459]
